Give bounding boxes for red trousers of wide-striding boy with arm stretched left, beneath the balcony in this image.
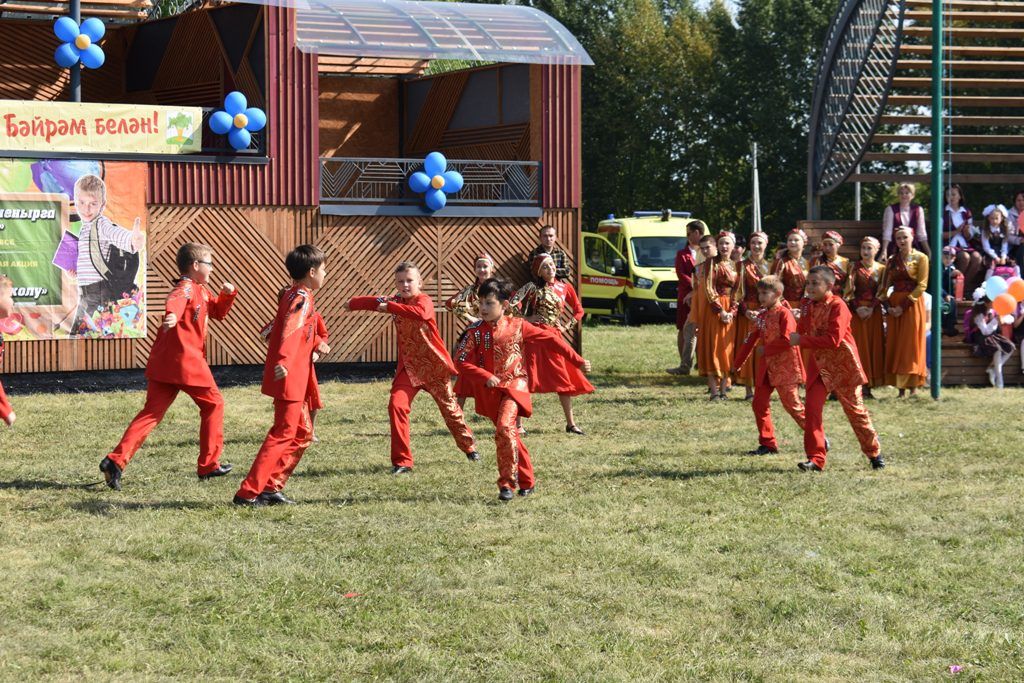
[387,368,476,467]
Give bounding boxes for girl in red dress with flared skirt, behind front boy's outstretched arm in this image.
[516,254,594,434]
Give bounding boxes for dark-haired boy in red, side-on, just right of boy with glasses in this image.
[232,245,331,506]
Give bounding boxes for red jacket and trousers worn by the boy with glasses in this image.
[108,278,238,476]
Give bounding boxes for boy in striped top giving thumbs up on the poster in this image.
[72,174,145,331]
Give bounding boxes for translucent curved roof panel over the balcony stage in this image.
[231,0,594,66]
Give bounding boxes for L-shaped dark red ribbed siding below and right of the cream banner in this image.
[148,7,319,206]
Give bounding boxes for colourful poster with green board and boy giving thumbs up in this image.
[0,159,146,341]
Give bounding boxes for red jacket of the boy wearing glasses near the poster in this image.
[145,278,238,387]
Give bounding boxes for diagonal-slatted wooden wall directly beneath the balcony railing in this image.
[302,210,580,362]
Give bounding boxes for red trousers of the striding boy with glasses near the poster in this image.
[108,380,224,476]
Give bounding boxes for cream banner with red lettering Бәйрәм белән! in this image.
[0,99,203,155]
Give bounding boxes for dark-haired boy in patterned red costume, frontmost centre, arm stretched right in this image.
[456,279,590,502]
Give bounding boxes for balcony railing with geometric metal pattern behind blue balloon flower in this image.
[321,157,541,207]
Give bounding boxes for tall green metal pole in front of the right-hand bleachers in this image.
[928,0,943,399]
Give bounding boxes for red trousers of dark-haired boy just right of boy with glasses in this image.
[238,398,312,499]
